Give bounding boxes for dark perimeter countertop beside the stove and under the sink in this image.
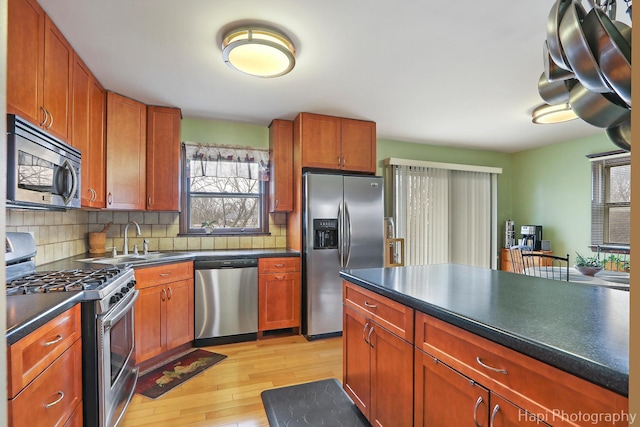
[6,249,300,345]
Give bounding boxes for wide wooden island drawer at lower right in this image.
[416,313,628,426]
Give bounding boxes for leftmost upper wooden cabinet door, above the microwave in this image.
[7,0,45,125]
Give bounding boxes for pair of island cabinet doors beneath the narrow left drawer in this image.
[343,307,413,426]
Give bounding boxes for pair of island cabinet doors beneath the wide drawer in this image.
[414,349,548,427]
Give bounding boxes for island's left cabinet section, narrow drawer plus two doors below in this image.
[343,282,413,426]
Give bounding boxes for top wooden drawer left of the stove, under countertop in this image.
[7,305,81,398]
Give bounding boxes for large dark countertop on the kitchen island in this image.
[340,264,629,396]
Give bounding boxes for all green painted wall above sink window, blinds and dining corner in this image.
[182,119,616,268]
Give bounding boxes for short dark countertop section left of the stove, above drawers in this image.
[6,292,84,345]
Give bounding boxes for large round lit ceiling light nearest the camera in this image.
[222,27,296,78]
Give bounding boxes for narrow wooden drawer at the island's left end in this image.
[343,281,413,343]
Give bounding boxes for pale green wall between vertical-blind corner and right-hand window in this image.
[511,132,617,260]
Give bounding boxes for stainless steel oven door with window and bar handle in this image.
[98,290,138,427]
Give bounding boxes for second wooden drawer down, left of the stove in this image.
[8,340,82,427]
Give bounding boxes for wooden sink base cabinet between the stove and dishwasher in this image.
[134,262,194,364]
